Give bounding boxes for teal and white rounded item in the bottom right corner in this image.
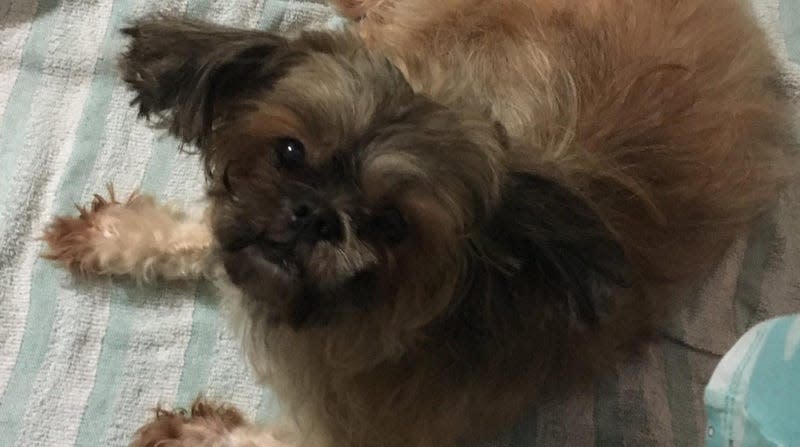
[705,315,800,447]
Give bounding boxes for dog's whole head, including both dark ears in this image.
[122,18,621,342]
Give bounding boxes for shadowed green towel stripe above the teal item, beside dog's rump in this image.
[733,213,778,335]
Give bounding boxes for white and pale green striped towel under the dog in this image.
[0,0,800,447]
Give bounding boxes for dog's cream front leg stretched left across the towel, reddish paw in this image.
[43,187,212,282]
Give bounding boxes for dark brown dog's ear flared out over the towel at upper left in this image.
[115,16,300,148]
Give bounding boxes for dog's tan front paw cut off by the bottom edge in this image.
[131,399,247,447]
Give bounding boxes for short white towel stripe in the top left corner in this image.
[0,1,36,123]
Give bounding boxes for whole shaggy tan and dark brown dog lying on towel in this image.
[45,0,794,447]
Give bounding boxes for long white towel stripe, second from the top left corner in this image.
[0,2,111,395]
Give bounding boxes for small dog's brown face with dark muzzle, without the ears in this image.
[207,52,503,326]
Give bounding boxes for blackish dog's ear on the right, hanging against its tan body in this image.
[473,173,631,327]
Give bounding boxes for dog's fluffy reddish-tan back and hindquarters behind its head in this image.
[346,0,796,279]
